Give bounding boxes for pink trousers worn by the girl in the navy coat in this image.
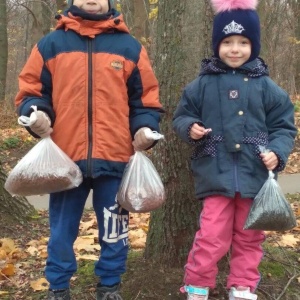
[184,193,265,292]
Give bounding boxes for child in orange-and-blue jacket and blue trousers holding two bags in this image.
[15,0,163,300]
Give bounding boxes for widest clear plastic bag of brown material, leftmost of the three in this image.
[4,137,82,196]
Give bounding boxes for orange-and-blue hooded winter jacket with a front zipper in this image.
[15,10,163,178]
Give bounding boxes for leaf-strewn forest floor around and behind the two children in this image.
[0,107,300,300]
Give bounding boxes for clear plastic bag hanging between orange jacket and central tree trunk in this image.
[117,151,165,213]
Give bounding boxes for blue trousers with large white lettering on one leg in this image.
[45,176,129,289]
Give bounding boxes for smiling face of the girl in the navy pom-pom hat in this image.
[219,35,251,68]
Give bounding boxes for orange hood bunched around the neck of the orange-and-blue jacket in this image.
[55,7,129,38]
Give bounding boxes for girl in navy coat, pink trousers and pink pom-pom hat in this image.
[173,0,297,300]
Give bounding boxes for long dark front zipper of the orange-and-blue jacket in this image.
[87,38,93,177]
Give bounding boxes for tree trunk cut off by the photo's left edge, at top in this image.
[0,0,8,101]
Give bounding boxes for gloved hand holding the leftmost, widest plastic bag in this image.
[30,110,53,138]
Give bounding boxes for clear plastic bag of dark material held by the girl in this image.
[244,171,297,231]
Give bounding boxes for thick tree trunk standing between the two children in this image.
[145,0,212,265]
